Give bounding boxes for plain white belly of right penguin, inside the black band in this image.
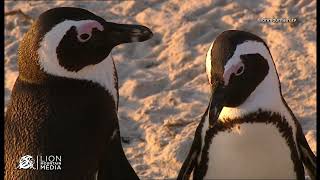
[205,123,296,179]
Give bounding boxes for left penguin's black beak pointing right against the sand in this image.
[104,22,153,45]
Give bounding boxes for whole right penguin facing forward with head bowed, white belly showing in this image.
[178,30,316,180]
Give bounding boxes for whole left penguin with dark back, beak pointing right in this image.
[4,7,152,180]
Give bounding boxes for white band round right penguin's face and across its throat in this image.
[219,41,297,151]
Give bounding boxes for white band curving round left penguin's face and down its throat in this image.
[38,20,118,107]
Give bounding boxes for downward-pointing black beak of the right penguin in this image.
[209,83,226,126]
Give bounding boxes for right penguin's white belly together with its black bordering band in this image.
[195,111,301,179]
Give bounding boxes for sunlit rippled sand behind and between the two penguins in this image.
[4,0,316,179]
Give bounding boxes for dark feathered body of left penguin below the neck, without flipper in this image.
[5,77,118,179]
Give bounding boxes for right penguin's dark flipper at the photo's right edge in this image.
[297,125,317,180]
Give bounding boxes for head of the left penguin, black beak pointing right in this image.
[19,7,152,78]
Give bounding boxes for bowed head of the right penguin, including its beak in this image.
[206,30,279,124]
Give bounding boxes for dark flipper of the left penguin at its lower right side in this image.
[98,130,139,180]
